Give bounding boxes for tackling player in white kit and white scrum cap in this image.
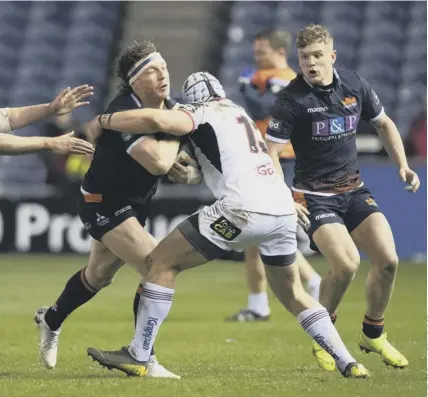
[88,72,368,378]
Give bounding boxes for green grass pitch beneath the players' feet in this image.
[0,255,426,397]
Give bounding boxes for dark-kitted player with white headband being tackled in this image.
[35,42,186,377]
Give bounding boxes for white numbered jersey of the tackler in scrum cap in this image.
[180,99,295,215]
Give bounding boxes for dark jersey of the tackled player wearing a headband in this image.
[82,89,187,202]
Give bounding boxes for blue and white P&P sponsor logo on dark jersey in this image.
[312,114,360,141]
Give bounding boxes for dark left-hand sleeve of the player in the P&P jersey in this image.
[266,97,299,143]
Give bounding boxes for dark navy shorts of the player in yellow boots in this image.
[293,187,381,251]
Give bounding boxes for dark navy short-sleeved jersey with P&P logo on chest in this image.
[266,70,383,193]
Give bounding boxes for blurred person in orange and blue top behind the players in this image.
[226,30,321,322]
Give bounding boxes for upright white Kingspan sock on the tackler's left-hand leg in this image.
[129,283,174,361]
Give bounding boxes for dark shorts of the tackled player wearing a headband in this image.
[79,194,151,241]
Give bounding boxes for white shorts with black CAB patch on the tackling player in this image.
[180,201,297,265]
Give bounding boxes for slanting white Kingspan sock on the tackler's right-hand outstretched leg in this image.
[297,307,356,372]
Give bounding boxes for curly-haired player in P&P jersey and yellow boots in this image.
[266,25,420,370]
